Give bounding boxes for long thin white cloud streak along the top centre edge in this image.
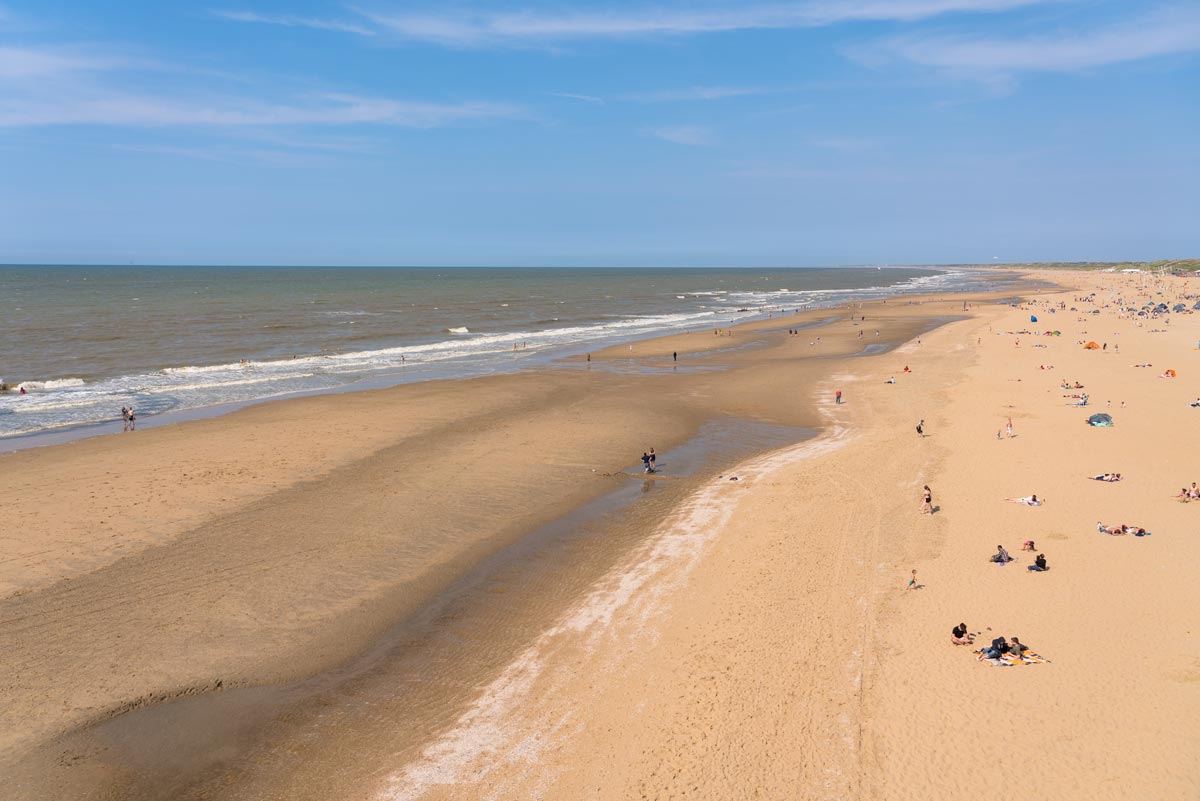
[355,0,1048,47]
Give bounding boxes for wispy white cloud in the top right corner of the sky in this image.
[852,8,1200,78]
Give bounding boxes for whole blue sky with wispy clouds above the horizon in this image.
[0,0,1200,266]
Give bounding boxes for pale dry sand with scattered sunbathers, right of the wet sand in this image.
[360,273,1200,800]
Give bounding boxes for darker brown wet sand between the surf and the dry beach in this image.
[0,300,993,797]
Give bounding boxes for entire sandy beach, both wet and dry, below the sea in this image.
[0,271,1200,800]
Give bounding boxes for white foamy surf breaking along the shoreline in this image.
[0,271,984,436]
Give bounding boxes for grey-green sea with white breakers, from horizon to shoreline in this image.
[0,265,1000,450]
